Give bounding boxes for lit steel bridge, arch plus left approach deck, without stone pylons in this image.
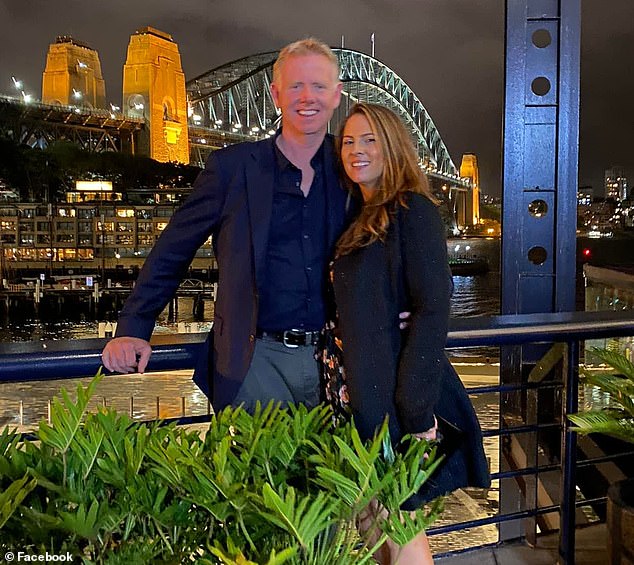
[0,40,477,225]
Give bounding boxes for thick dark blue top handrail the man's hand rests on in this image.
[0,311,634,382]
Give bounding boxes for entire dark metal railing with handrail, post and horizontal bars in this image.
[0,311,634,564]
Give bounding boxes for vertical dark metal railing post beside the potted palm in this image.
[559,341,579,565]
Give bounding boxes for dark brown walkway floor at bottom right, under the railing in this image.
[435,524,608,565]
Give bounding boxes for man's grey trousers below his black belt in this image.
[232,338,319,412]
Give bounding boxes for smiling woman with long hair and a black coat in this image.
[333,103,490,565]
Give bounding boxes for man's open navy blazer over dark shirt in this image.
[116,135,351,410]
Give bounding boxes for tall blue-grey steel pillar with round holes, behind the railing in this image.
[500,0,580,539]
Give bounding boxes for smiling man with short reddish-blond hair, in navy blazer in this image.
[102,39,350,410]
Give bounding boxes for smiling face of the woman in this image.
[341,114,385,200]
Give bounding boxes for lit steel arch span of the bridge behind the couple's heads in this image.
[187,49,470,220]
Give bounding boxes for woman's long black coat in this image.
[333,193,490,507]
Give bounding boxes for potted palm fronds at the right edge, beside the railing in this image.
[568,348,634,443]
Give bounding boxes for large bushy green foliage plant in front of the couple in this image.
[0,373,441,565]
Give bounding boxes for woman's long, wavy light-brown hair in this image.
[336,102,436,257]
